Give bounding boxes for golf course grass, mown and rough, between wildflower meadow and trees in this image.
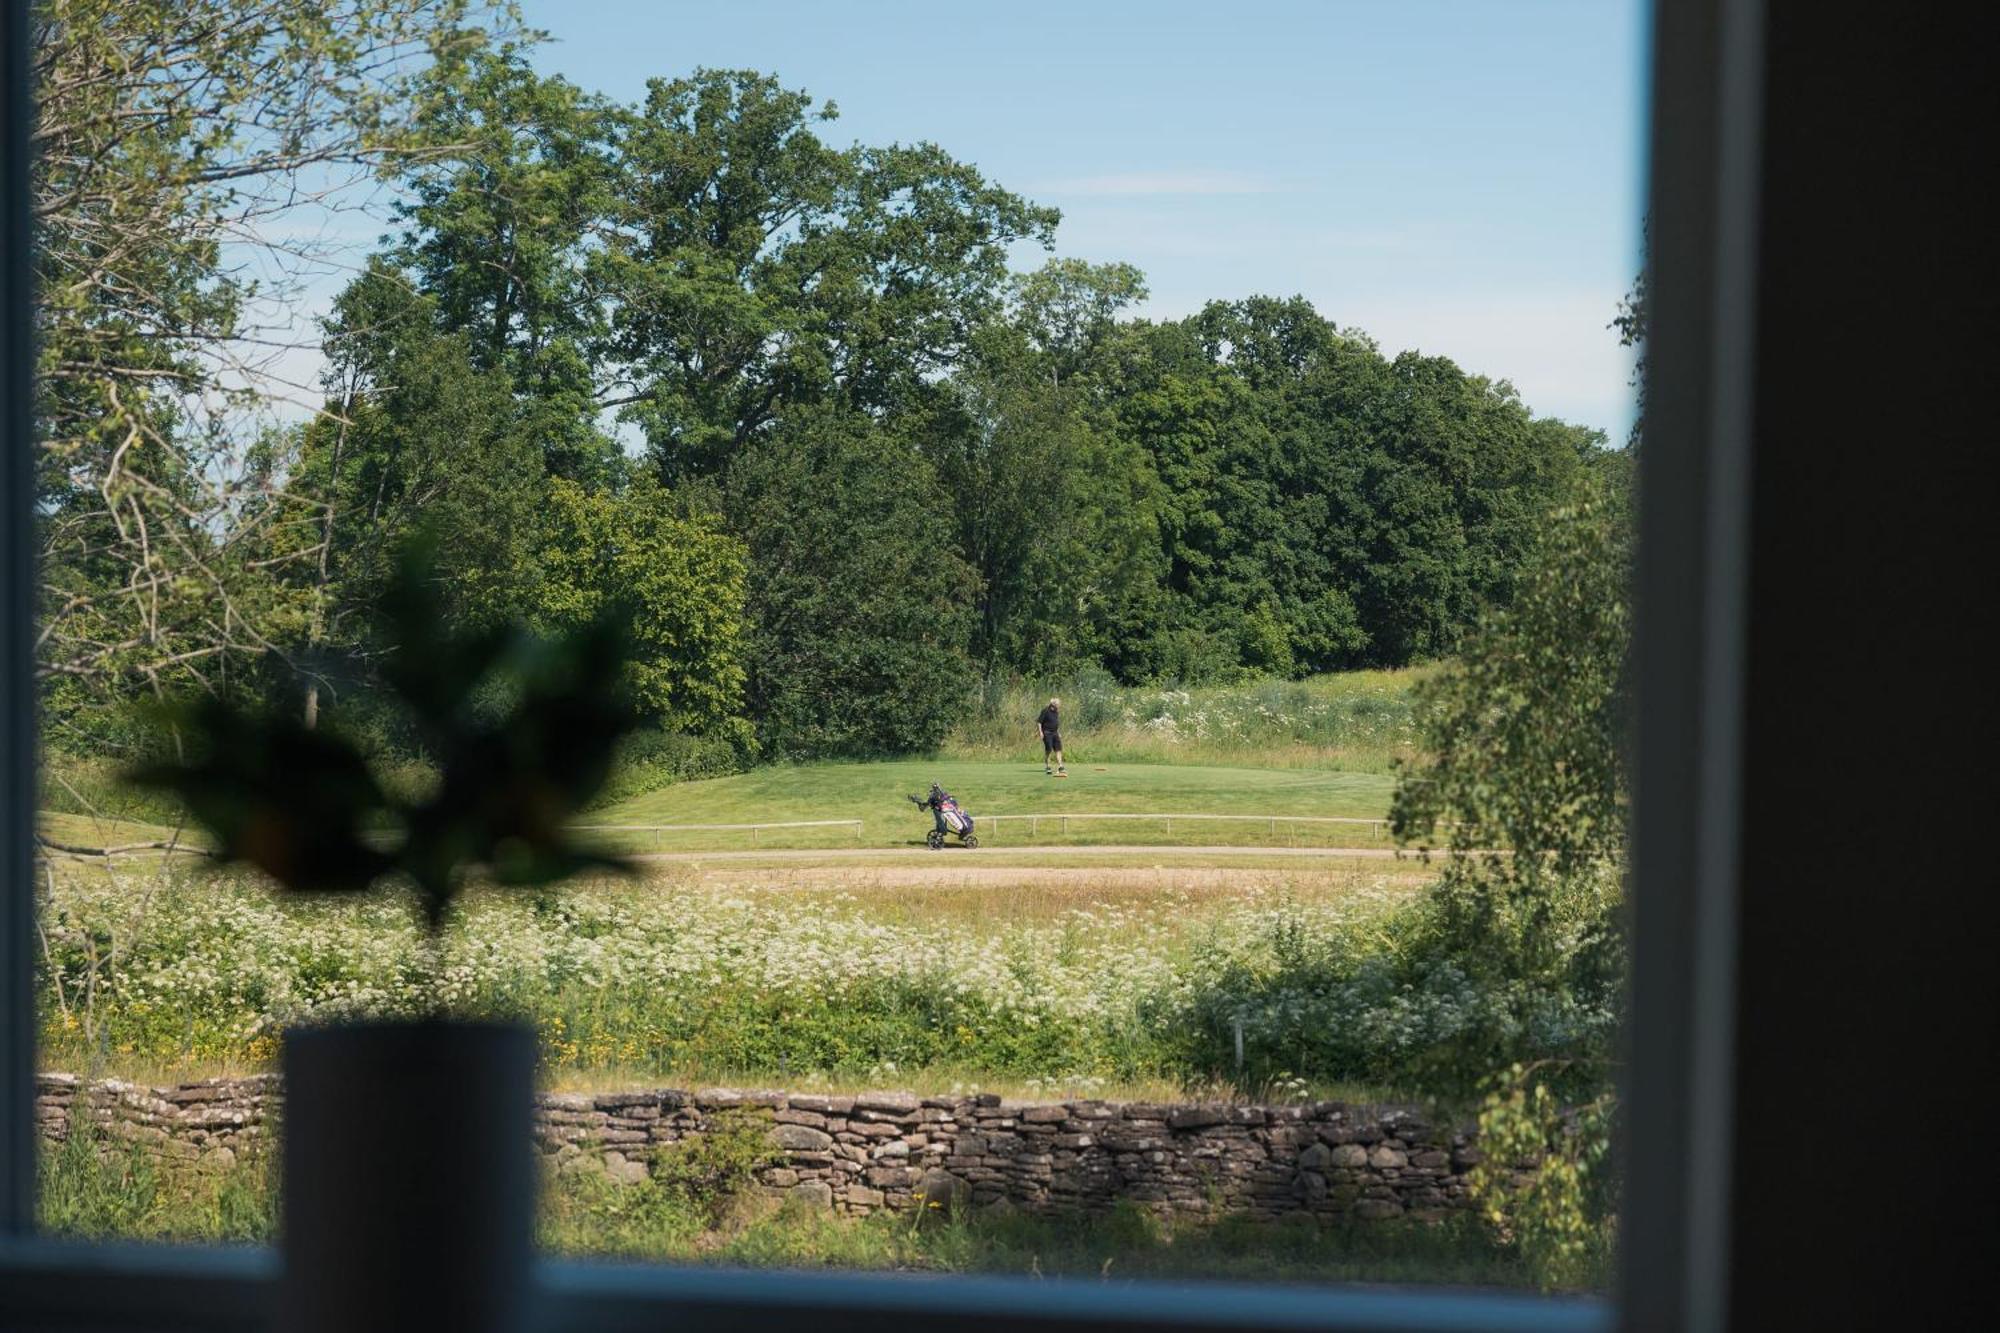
[42,669,1428,853]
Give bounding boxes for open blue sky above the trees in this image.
[524,0,1646,440]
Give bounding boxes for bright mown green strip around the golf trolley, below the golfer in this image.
[588,759,1394,851]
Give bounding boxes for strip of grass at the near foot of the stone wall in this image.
[40,1133,1560,1287]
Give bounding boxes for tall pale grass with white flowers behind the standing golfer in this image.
[944,667,1430,773]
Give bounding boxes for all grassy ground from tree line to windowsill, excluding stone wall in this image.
[27,673,1592,1287]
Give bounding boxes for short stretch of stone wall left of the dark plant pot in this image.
[34,1073,278,1169]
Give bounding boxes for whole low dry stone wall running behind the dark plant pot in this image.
[38,1075,1478,1221]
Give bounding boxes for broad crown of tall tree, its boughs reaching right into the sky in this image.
[590,70,1058,480]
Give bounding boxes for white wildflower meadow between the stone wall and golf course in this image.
[31,861,1528,1095]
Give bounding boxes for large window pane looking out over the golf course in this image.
[34,0,1646,1291]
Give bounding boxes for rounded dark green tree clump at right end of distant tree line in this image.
[1110,296,1602,675]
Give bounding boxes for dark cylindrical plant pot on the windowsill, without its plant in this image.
[280,1021,536,1333]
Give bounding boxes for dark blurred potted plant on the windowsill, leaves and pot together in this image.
[132,548,632,1331]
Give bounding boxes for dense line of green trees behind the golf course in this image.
[31,13,1616,755]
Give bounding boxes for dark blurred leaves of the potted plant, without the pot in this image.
[130,540,634,931]
